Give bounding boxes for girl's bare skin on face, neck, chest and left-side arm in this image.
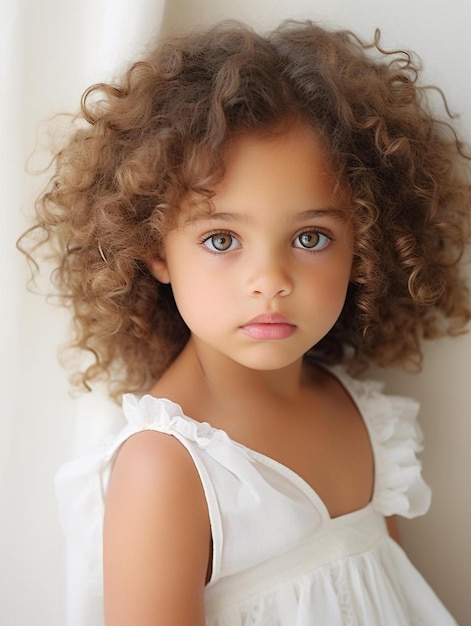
[104,125,398,626]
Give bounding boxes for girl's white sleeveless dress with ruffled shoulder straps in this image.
[56,368,456,626]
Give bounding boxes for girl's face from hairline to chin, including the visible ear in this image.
[151,125,353,370]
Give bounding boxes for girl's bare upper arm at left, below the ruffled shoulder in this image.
[103,431,214,626]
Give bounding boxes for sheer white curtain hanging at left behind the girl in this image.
[0,0,165,626]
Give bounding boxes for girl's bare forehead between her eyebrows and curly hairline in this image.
[183,124,347,221]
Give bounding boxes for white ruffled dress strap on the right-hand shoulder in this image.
[333,368,431,518]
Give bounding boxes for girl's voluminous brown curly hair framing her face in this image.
[20,22,471,396]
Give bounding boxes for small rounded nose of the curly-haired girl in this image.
[247,254,293,298]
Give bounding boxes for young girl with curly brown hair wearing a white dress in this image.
[24,23,471,626]
